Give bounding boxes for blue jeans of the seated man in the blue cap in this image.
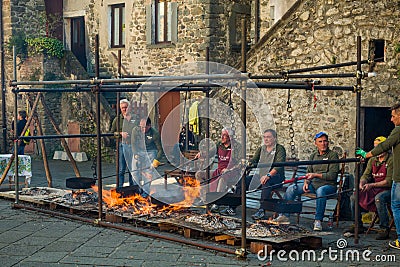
[285,181,336,221]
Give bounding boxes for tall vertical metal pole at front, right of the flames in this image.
[240,17,247,256]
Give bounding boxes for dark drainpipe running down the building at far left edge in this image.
[0,1,8,153]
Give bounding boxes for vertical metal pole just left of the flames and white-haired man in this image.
[95,34,103,220]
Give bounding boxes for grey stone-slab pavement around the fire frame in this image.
[0,160,400,267]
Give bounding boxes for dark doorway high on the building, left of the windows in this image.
[71,17,87,70]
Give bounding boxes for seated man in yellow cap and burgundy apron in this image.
[344,136,393,240]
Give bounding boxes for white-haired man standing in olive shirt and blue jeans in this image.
[111,99,136,187]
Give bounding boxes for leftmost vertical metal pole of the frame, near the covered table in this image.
[12,45,19,204]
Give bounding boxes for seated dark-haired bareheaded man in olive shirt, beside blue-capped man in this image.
[250,129,286,220]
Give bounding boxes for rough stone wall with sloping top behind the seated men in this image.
[247,0,400,162]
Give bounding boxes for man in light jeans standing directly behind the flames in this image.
[132,118,163,197]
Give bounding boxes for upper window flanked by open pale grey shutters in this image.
[146,0,178,44]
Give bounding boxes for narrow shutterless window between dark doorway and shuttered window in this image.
[111,4,125,47]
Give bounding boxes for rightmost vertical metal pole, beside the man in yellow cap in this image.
[354,36,361,244]
